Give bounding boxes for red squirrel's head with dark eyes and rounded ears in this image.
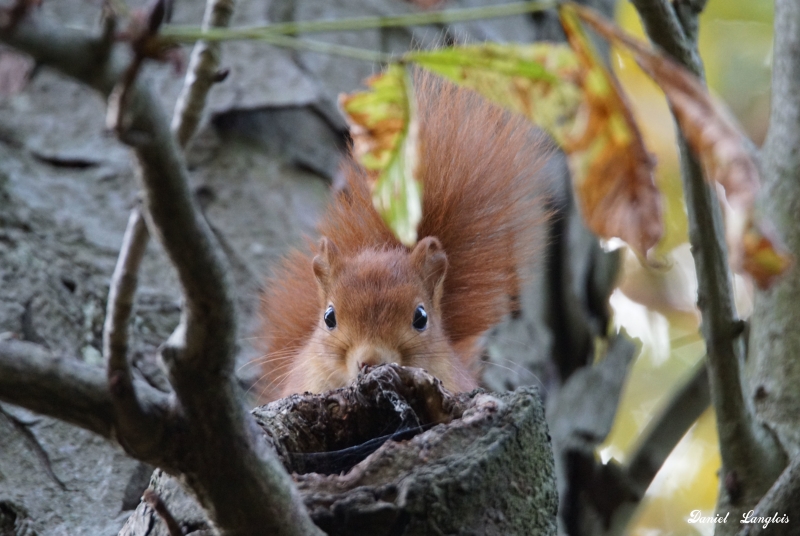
[290,237,471,392]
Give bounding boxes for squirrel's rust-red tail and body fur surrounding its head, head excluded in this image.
[262,73,547,398]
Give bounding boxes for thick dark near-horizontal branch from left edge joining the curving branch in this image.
[0,340,169,440]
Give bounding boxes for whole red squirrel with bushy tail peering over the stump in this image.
[261,73,546,400]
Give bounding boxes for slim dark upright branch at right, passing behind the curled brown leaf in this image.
[633,0,785,517]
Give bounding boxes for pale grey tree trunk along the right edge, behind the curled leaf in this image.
[747,0,800,458]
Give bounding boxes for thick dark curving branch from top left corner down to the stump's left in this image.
[0,6,320,535]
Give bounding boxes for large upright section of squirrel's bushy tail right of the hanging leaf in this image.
[416,75,547,357]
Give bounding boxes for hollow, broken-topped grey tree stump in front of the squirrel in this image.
[120,365,558,536]
